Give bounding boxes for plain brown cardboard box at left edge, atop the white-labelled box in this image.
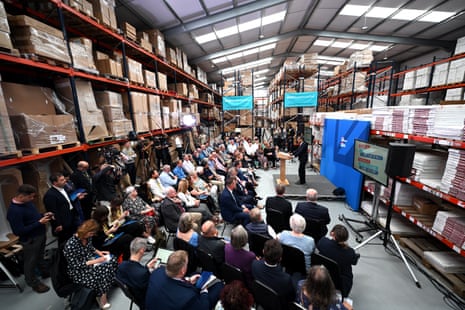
[1,82,57,115]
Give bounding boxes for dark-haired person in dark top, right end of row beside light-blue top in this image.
[317,224,360,297]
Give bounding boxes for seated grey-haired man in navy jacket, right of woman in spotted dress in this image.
[116,237,157,308]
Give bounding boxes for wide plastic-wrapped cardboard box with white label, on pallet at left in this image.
[10,114,78,149]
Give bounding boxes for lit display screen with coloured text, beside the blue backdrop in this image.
[353,140,389,186]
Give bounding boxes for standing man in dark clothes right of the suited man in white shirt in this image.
[71,160,95,220]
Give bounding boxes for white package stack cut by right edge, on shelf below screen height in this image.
[441,148,465,200]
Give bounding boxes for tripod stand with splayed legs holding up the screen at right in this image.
[354,178,421,288]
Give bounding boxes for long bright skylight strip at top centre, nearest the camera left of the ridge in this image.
[195,11,286,44]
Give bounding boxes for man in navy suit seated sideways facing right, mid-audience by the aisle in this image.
[220,176,250,226]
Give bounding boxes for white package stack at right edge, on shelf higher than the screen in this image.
[429,104,465,140]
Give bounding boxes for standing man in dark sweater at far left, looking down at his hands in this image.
[7,184,53,293]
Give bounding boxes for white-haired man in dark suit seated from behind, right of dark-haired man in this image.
[295,188,331,243]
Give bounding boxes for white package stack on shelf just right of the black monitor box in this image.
[412,151,447,188]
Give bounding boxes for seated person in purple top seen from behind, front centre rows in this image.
[224,225,256,284]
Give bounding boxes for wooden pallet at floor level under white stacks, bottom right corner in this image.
[399,238,465,298]
